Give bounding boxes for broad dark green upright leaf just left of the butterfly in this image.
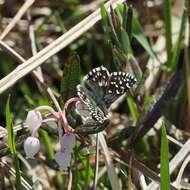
[61,54,80,103]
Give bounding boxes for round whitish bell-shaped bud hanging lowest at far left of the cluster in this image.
[24,137,40,159]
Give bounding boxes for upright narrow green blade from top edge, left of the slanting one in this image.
[164,0,172,65]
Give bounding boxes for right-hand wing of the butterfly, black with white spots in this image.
[104,72,137,107]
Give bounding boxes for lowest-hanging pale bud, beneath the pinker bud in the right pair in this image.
[55,151,71,171]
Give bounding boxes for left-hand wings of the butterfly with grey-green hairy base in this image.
[77,66,110,123]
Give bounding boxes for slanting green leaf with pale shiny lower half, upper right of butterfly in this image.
[132,16,160,62]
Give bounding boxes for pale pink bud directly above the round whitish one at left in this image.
[26,110,42,132]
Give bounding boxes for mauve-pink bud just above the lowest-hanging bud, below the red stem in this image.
[60,133,76,153]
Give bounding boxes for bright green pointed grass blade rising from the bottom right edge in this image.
[160,124,171,190]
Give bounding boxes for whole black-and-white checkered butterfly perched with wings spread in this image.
[77,66,137,124]
